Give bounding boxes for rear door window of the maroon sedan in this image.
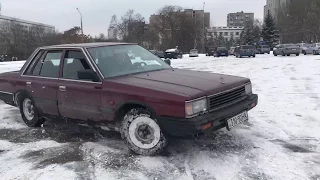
[32,51,62,78]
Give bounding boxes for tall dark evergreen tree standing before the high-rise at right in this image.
[262,12,279,47]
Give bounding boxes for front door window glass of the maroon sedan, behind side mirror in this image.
[62,50,92,81]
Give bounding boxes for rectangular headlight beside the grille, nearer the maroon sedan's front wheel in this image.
[185,98,208,117]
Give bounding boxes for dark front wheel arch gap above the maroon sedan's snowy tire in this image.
[114,101,157,121]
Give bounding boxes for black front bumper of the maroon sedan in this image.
[158,94,258,137]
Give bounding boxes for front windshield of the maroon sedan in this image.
[88,45,171,77]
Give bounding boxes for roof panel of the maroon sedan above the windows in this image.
[42,42,135,48]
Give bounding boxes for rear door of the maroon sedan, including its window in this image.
[23,50,63,116]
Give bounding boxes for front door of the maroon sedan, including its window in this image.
[58,49,102,121]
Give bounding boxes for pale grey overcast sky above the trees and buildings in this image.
[0,0,266,35]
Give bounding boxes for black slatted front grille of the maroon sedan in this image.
[209,86,246,109]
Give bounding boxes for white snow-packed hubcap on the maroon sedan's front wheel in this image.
[129,117,161,149]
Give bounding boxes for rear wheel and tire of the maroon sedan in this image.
[18,94,45,127]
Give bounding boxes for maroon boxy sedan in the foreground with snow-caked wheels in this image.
[0,43,258,155]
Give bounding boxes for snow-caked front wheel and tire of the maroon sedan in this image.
[120,108,168,156]
